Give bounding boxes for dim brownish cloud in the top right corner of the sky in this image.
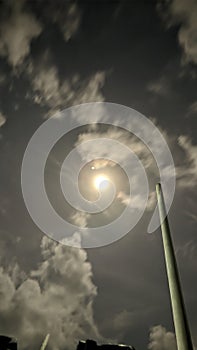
[158,0,197,64]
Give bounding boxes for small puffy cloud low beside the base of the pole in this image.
[148,325,177,350]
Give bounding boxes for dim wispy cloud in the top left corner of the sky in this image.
[0,0,81,69]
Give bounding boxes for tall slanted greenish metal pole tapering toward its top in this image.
[156,184,193,350]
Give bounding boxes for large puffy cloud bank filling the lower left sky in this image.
[0,236,100,350]
